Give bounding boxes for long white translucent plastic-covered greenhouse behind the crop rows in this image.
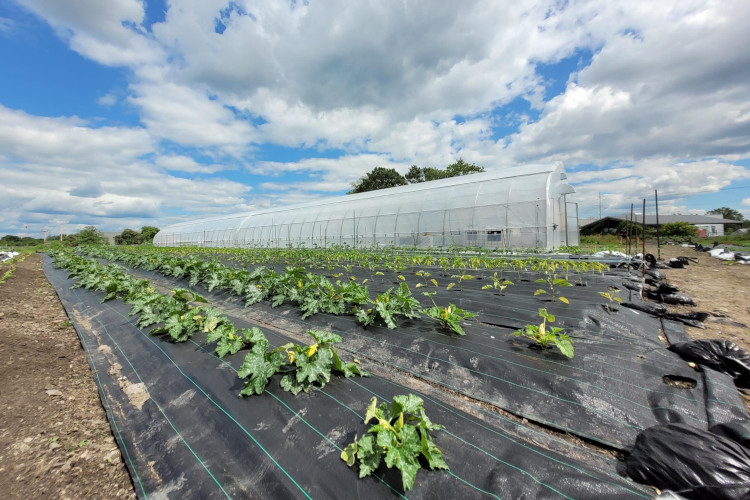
[154,162,578,250]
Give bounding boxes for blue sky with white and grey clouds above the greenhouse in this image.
[0,0,750,237]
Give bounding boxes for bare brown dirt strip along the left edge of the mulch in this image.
[0,255,135,499]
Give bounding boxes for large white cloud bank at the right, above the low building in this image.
[508,2,750,165]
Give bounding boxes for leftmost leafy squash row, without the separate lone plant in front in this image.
[54,252,364,395]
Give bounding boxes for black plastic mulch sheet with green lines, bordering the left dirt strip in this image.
[45,259,650,498]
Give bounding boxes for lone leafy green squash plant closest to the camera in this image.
[341,394,448,491]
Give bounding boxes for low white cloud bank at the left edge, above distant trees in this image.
[0,106,251,229]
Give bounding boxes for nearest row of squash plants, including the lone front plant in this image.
[52,251,448,491]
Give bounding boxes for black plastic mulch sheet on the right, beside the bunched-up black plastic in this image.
[114,260,746,450]
